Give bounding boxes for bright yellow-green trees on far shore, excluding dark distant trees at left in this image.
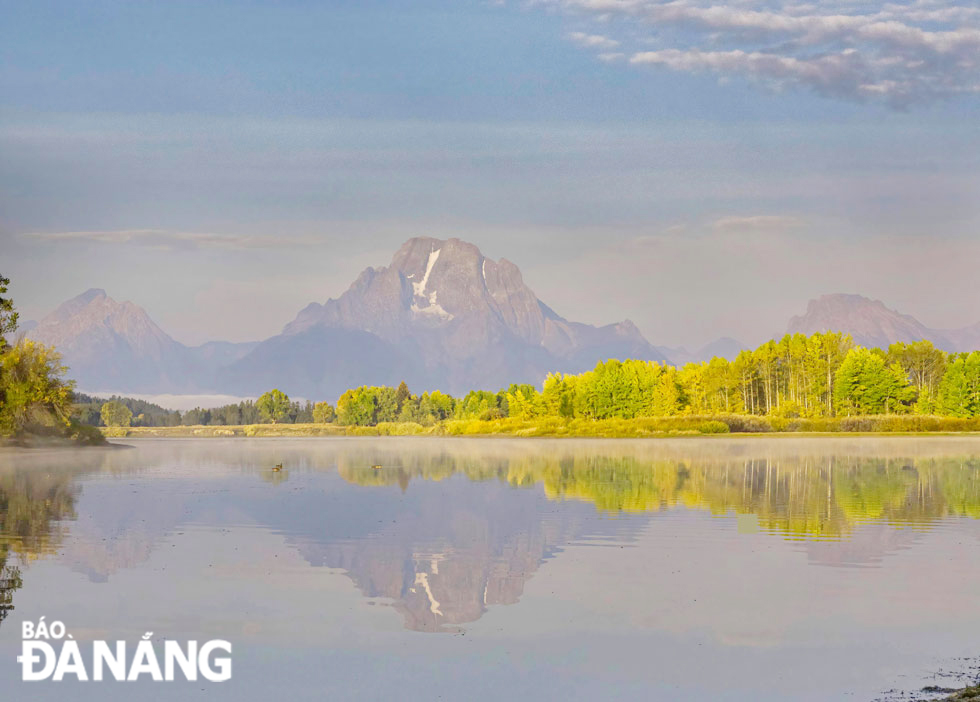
[312,332,980,426]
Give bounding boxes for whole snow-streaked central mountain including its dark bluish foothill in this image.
[219,237,665,398]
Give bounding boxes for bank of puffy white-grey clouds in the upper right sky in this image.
[538,0,980,107]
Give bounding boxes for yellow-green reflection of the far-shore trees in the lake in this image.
[338,456,980,537]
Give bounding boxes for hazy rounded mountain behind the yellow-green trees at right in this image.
[786,294,980,351]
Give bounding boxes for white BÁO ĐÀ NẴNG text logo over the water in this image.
[17,617,231,682]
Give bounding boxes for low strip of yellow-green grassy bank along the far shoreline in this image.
[102,415,980,438]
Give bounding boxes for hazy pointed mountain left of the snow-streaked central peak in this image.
[26,288,255,393]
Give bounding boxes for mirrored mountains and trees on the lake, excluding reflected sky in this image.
[0,439,980,631]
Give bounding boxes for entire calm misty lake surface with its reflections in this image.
[0,437,980,702]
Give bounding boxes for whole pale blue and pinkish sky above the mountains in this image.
[0,0,980,349]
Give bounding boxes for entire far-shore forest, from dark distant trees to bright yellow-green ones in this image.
[88,332,980,433]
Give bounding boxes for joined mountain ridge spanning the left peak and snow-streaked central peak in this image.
[28,237,667,401]
